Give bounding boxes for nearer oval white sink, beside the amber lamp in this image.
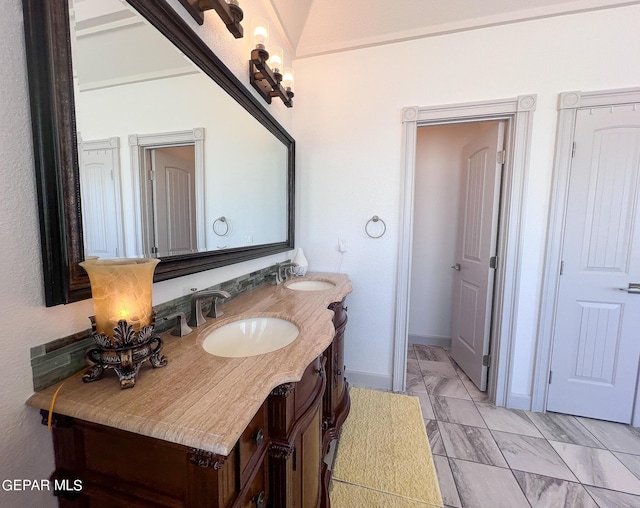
[202,317,299,358]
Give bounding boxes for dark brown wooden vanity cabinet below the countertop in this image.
[41,300,349,508]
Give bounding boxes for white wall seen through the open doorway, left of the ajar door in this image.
[409,123,482,344]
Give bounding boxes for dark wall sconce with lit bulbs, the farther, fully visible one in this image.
[249,18,294,108]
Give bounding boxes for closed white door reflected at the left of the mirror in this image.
[78,137,124,258]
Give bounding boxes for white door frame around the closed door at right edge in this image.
[531,88,640,418]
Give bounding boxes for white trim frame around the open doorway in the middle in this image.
[392,94,537,409]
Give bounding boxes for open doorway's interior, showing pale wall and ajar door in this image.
[409,121,507,391]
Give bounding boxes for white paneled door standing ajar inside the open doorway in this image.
[451,122,505,391]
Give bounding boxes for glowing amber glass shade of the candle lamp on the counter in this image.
[80,258,160,339]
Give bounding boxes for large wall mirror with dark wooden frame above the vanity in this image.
[23,0,295,306]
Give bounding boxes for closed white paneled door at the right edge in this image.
[547,105,640,423]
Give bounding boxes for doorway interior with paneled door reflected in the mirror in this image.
[151,146,198,257]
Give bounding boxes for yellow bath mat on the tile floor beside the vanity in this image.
[331,388,442,508]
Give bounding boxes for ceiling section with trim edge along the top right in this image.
[269,0,640,58]
